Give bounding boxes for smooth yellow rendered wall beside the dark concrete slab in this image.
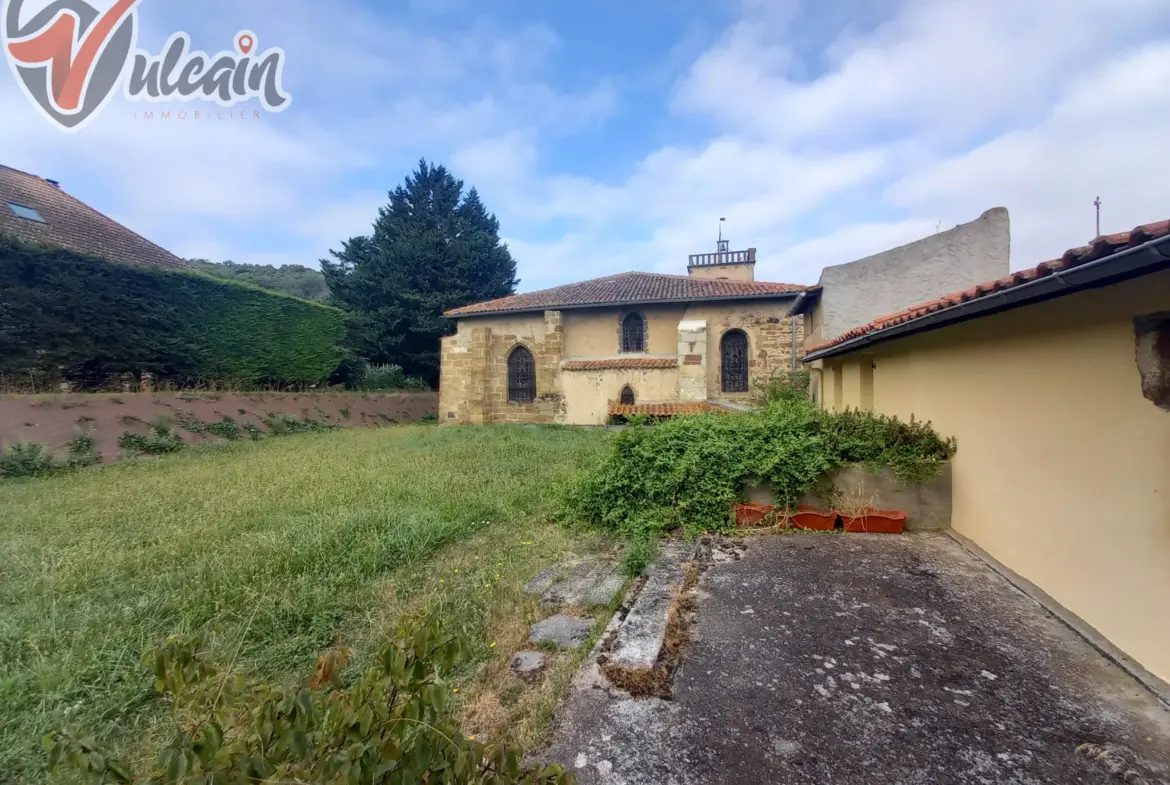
[826,271,1170,681]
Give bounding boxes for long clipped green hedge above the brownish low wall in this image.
[0,236,345,385]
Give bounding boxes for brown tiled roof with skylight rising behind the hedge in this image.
[0,166,191,268]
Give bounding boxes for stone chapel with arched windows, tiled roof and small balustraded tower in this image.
[439,249,805,425]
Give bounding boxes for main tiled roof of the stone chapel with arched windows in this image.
[447,273,806,316]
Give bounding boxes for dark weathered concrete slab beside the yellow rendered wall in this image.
[541,535,1170,785]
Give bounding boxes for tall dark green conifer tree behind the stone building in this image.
[321,159,518,384]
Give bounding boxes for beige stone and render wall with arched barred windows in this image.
[439,297,804,425]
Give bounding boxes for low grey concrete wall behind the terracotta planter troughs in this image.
[744,463,951,531]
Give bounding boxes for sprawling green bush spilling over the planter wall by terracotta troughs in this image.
[565,393,955,539]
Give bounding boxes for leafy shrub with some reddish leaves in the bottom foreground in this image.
[44,618,574,785]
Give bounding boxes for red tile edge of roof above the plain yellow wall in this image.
[808,220,1170,354]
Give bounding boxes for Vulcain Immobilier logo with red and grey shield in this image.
[0,0,293,131]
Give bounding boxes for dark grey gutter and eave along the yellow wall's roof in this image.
[805,235,1170,363]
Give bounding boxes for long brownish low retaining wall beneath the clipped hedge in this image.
[0,392,439,462]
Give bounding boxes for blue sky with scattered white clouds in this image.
[0,0,1170,291]
